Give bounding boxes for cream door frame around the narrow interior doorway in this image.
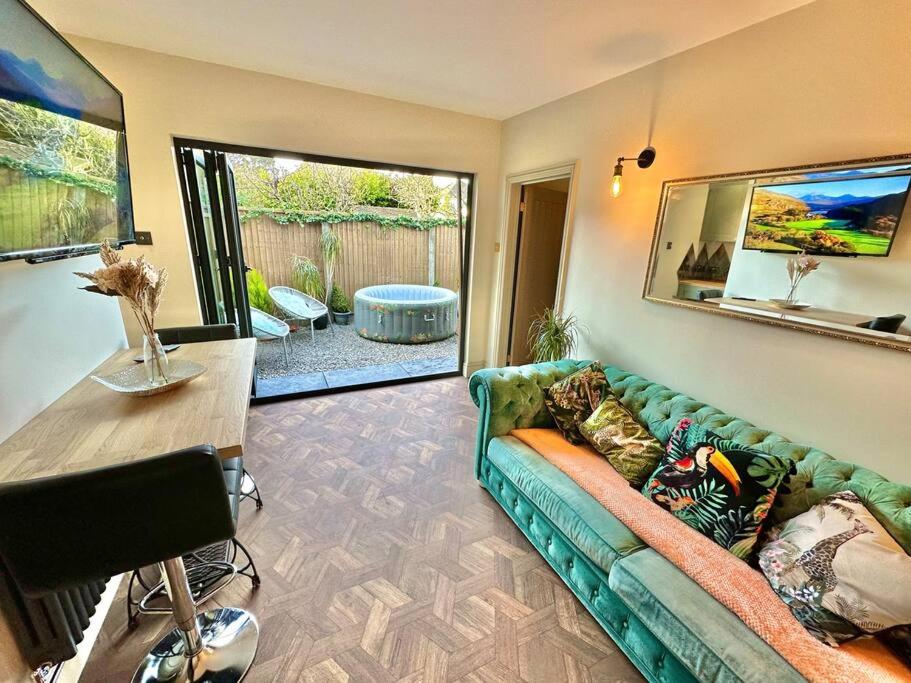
[492,159,579,367]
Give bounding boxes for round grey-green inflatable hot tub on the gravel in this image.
[354,285,459,344]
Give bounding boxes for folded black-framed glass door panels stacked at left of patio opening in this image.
[177,147,252,337]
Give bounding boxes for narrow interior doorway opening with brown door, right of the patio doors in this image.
[506,177,569,365]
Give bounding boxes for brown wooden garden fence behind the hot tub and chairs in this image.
[241,211,462,298]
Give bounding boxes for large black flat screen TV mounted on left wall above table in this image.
[0,0,134,261]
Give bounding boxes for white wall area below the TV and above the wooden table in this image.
[0,256,126,441]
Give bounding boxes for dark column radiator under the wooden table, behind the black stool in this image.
[0,562,107,669]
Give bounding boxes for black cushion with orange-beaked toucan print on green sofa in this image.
[642,418,794,560]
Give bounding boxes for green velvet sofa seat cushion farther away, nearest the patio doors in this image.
[487,436,646,573]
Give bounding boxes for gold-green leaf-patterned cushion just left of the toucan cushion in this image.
[579,391,664,487]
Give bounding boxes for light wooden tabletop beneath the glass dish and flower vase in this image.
[0,339,256,482]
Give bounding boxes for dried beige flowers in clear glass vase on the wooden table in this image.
[76,242,168,386]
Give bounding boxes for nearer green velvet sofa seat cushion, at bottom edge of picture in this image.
[608,548,804,683]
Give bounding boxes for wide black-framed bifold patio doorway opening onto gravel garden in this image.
[175,140,473,401]
